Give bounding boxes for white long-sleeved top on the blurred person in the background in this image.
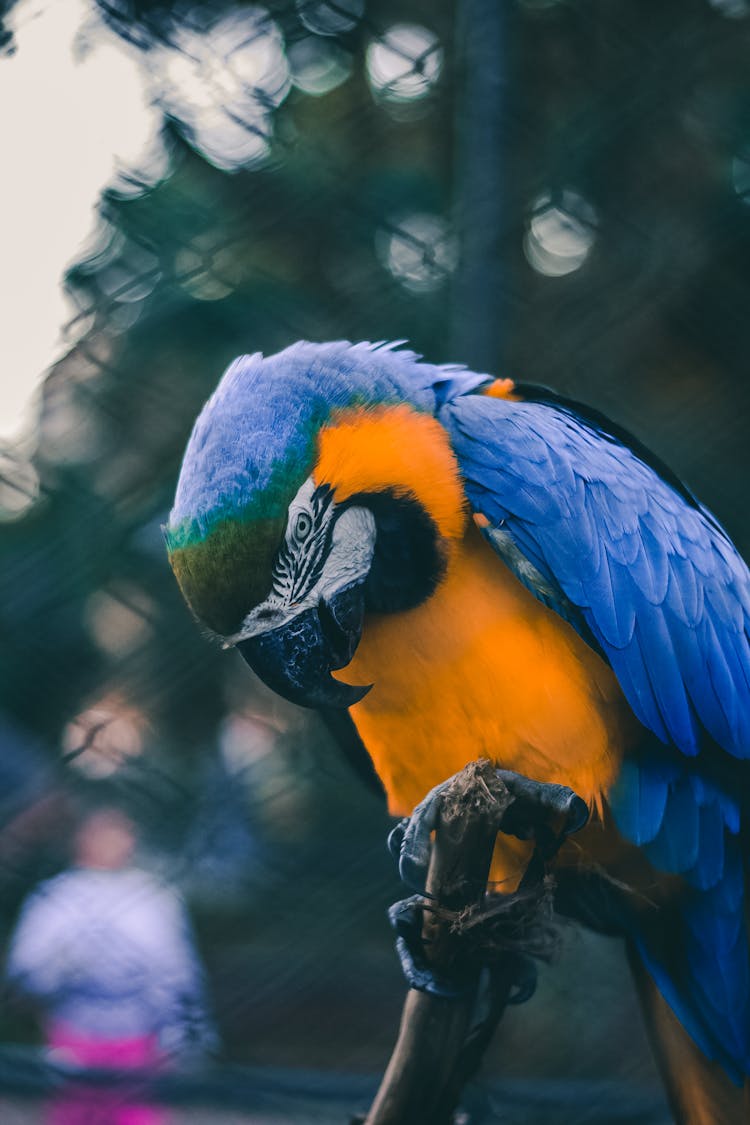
[7,867,213,1050]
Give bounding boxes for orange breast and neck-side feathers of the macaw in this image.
[316,407,635,878]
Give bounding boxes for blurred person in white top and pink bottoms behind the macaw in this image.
[7,807,216,1125]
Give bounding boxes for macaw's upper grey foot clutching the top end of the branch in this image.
[388,770,588,897]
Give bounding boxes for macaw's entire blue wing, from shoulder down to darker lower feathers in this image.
[440,395,750,1079]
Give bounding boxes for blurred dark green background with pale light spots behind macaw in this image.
[0,0,750,1125]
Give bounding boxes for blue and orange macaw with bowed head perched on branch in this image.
[164,341,750,1123]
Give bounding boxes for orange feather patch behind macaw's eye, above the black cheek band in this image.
[313,405,468,540]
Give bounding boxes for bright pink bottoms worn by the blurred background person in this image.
[47,1023,169,1125]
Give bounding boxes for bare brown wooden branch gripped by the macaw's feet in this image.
[365,761,512,1125]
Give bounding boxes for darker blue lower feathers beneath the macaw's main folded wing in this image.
[609,747,750,1081]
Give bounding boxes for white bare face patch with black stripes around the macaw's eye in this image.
[227,477,376,645]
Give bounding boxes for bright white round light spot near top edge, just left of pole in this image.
[367,24,443,106]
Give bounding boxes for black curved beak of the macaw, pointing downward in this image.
[237,583,372,708]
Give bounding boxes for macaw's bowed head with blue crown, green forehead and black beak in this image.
[165,343,485,708]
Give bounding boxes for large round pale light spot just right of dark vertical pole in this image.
[524,190,596,278]
